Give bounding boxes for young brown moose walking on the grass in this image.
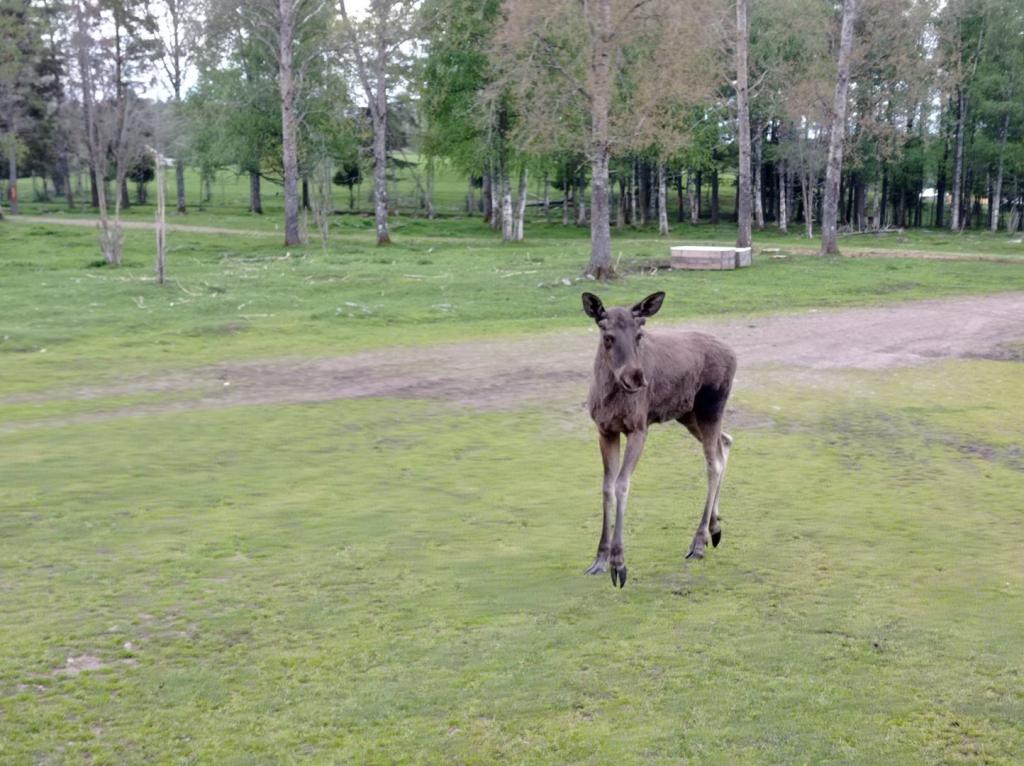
[583,292,736,588]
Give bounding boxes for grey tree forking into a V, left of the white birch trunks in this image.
[339,0,416,245]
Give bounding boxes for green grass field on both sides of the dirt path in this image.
[0,206,1024,765]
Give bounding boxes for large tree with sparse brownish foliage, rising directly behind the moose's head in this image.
[496,0,719,279]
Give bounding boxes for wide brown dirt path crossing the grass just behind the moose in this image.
[0,293,1024,431]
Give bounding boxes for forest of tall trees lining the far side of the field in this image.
[0,0,1024,276]
